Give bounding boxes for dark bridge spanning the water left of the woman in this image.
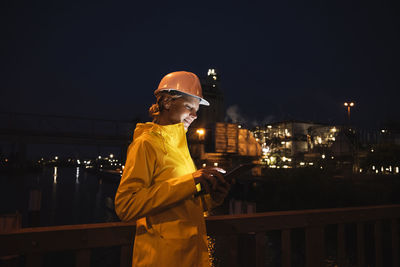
[0,113,137,161]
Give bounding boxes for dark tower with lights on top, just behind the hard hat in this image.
[193,69,225,128]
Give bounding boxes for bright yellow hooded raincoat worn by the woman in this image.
[115,122,216,267]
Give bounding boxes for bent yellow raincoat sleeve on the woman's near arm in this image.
[115,140,196,221]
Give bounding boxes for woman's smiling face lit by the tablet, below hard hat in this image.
[166,95,200,130]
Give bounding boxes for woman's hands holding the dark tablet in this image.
[193,167,229,194]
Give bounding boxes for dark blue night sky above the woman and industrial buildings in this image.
[0,0,400,128]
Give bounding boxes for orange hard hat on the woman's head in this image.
[154,71,210,106]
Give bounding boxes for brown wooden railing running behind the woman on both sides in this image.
[0,205,400,267]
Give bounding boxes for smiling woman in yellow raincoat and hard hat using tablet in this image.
[115,71,229,267]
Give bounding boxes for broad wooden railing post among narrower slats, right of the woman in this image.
[306,226,325,267]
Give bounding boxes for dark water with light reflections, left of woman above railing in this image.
[0,167,118,227]
